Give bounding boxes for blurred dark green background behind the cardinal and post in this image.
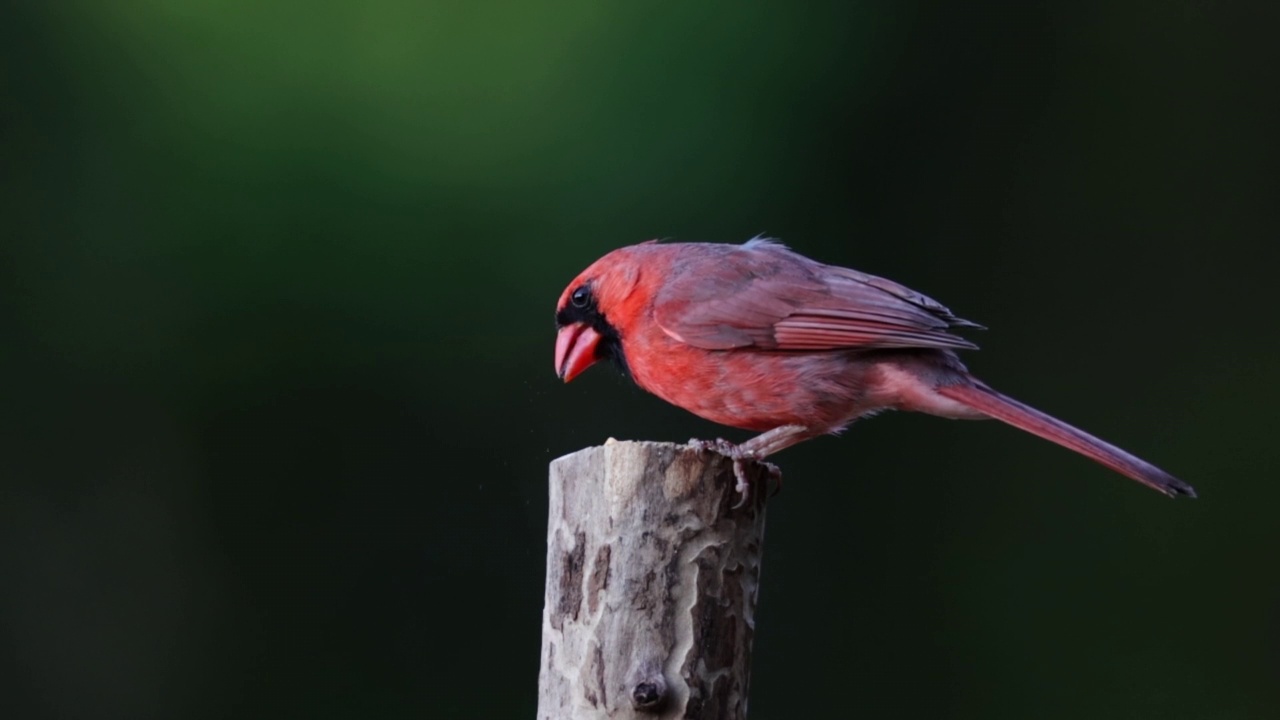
[0,0,1280,720]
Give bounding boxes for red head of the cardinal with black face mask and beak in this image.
[556,243,649,382]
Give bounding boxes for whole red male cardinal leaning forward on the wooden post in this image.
[556,238,1196,501]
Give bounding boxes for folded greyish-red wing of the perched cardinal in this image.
[654,240,980,350]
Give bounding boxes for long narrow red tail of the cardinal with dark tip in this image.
[936,380,1196,497]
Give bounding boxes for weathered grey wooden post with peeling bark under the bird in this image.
[538,439,768,720]
